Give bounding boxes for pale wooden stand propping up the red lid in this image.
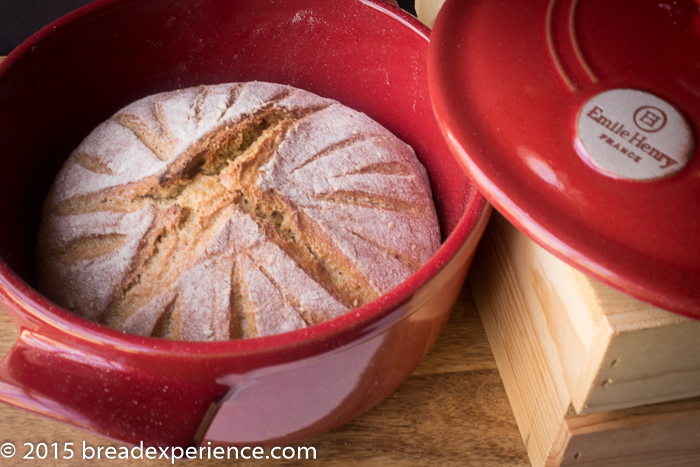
[469,213,700,466]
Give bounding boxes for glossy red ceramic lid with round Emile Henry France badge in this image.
[428,0,700,319]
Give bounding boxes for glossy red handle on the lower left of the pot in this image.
[0,329,227,447]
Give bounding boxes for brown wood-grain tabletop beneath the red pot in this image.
[0,51,530,467]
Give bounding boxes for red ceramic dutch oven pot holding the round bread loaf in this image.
[0,0,489,446]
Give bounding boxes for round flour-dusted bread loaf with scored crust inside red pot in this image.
[37,82,440,341]
